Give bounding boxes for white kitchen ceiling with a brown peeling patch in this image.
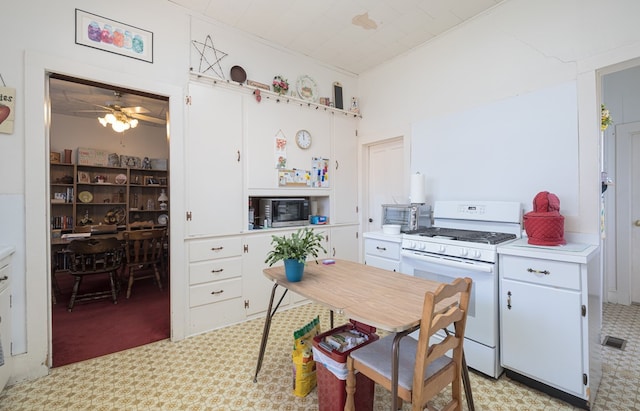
[169,0,505,74]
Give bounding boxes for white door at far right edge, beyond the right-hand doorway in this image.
[614,122,640,304]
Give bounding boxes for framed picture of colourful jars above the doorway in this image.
[76,9,153,63]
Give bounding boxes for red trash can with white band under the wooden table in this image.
[313,320,379,411]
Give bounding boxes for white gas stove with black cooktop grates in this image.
[400,201,522,378]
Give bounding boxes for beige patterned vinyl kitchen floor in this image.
[0,304,640,411]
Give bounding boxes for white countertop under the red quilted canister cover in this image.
[498,237,600,264]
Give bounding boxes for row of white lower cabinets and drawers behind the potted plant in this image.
[186,225,358,335]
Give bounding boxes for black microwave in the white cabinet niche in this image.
[258,198,309,228]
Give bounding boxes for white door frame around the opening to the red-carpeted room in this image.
[24,51,187,378]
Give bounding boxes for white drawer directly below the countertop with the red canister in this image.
[500,255,580,290]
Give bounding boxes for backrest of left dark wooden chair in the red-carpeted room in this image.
[67,237,123,274]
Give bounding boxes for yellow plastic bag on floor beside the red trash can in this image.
[291,316,320,397]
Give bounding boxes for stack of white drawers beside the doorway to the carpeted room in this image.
[188,237,245,335]
